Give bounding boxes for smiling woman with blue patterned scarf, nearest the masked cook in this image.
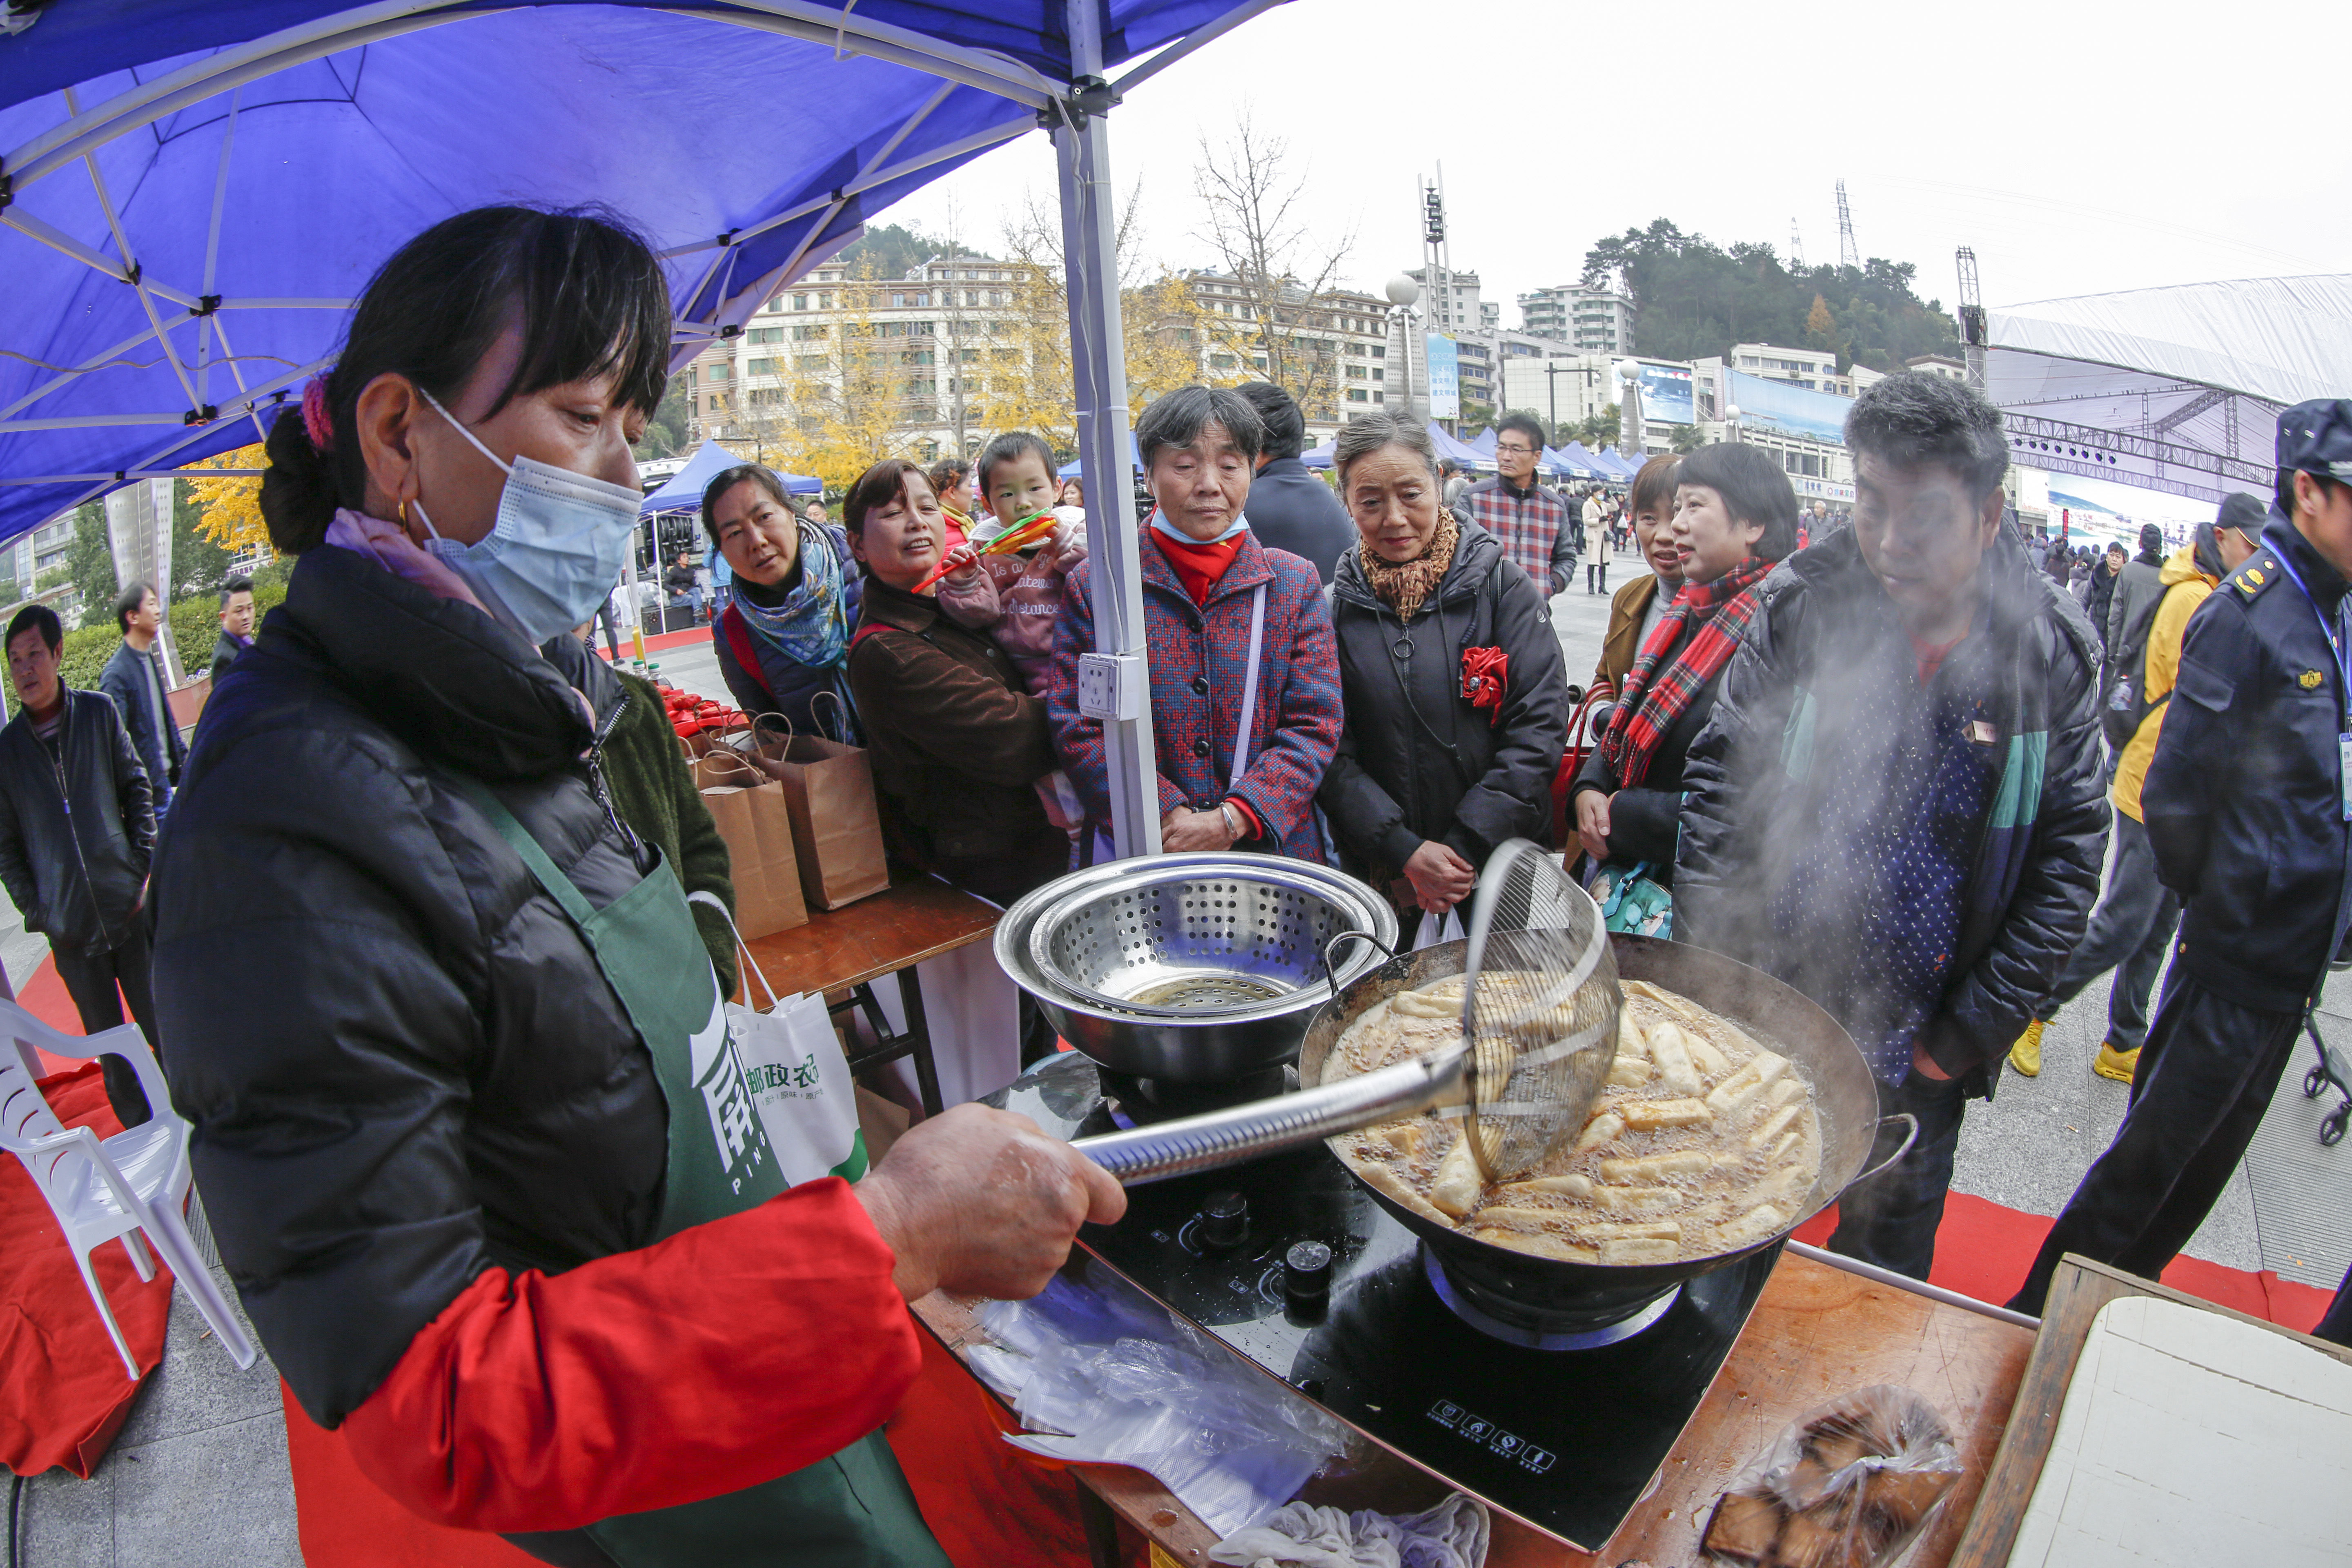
[703,463,861,743]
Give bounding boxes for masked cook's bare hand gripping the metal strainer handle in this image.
[851,1105,1127,1300]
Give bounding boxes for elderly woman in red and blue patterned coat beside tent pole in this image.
[1047,385,1341,860]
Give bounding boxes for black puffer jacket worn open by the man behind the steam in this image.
[1675,529,2107,1093]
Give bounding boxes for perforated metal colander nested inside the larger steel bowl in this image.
[1028,856,1392,1018]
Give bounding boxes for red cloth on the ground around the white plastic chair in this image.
[0,1062,172,1481]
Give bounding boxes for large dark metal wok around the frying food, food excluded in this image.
[1298,933,1917,1321]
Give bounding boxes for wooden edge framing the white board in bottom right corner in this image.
[1950,1253,2352,1568]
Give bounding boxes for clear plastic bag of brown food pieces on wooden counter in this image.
[1705,1385,1959,1568]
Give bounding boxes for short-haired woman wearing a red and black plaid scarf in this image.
[1571,442,1797,902]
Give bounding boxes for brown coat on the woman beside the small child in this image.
[849,576,1068,895]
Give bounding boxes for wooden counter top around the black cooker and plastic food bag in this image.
[915,1255,2034,1568]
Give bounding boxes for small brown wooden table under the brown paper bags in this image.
[736,872,1002,1117]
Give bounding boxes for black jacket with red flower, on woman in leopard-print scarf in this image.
[1315,519,1569,886]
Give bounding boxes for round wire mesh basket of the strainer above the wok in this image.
[1463,839,1625,1183]
